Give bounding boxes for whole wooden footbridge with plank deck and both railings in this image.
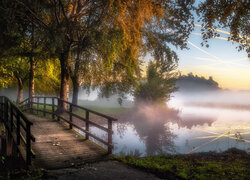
[0,96,116,169]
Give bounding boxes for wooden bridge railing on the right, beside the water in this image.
[21,96,117,154]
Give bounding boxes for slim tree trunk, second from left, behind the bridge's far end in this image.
[29,57,35,107]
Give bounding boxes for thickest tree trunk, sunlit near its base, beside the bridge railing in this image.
[59,48,70,110]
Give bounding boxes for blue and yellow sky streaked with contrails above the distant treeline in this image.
[176,26,250,90]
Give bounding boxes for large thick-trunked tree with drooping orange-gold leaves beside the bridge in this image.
[6,0,193,108]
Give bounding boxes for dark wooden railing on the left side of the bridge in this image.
[0,96,35,165]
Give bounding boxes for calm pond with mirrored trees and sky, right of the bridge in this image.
[84,93,250,156]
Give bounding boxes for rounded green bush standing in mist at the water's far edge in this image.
[134,58,178,104]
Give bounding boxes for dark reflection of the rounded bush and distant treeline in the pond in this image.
[117,105,215,156]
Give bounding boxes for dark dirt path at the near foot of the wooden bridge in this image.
[44,161,159,180]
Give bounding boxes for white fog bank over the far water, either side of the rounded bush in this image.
[76,89,250,110]
